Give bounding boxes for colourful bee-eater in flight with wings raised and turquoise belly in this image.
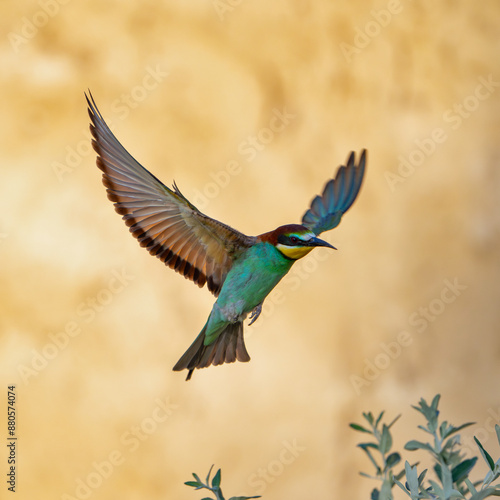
[85,93,366,380]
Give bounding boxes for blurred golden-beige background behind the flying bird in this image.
[0,0,500,500]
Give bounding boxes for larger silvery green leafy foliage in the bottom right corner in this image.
[350,394,500,500]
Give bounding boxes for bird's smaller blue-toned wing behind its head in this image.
[302,149,366,235]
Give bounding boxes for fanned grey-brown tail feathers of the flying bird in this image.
[173,321,250,380]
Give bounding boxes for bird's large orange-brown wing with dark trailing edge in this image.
[85,92,255,296]
